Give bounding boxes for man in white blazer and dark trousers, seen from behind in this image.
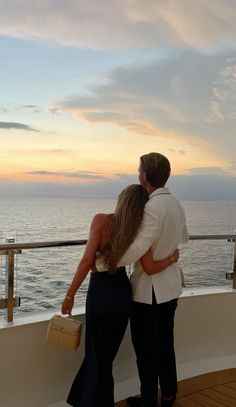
[121,153,188,407]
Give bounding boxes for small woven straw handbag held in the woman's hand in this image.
[46,315,82,350]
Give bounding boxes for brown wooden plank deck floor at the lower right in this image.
[116,369,236,407]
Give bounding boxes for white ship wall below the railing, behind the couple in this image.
[0,288,236,407]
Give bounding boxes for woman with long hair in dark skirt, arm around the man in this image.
[62,185,178,407]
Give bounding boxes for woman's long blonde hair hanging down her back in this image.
[97,184,148,270]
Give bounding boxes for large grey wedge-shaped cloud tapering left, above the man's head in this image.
[53,49,236,154]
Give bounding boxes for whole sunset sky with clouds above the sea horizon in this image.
[0,0,236,200]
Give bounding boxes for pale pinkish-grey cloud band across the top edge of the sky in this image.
[0,0,236,50]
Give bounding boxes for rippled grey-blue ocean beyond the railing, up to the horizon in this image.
[0,197,236,313]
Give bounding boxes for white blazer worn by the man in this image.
[119,188,189,304]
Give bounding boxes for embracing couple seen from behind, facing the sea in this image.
[62,153,188,407]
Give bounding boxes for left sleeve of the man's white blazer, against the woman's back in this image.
[118,203,159,266]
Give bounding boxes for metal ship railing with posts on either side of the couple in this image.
[0,234,236,322]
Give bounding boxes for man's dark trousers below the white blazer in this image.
[131,292,178,407]
